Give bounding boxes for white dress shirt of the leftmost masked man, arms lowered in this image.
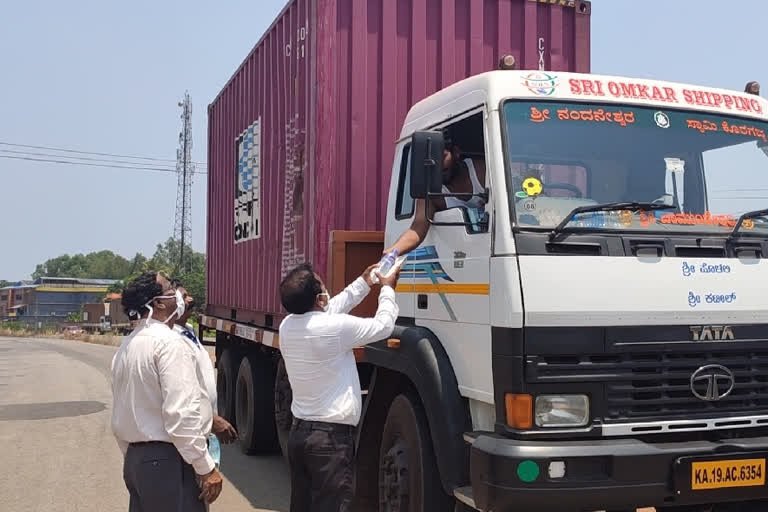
[112,320,214,475]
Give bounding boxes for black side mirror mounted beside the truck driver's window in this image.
[411,131,445,199]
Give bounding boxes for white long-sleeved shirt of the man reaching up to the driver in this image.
[280,278,399,426]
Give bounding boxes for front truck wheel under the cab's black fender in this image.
[379,395,454,512]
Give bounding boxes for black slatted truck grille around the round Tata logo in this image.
[528,345,768,423]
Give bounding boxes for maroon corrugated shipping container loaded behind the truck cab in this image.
[208,0,591,321]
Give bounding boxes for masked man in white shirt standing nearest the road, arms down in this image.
[112,273,222,512]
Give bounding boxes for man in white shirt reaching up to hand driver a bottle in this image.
[280,265,399,512]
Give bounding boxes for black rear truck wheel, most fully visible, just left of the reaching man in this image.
[235,355,279,454]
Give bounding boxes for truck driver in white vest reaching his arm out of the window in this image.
[384,129,485,256]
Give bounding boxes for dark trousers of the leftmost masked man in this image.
[123,442,208,512]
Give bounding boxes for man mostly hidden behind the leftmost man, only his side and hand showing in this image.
[173,282,237,444]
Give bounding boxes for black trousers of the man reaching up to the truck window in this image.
[288,420,355,512]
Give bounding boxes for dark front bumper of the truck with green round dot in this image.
[470,435,768,512]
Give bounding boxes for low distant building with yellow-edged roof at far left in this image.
[0,277,116,327]
